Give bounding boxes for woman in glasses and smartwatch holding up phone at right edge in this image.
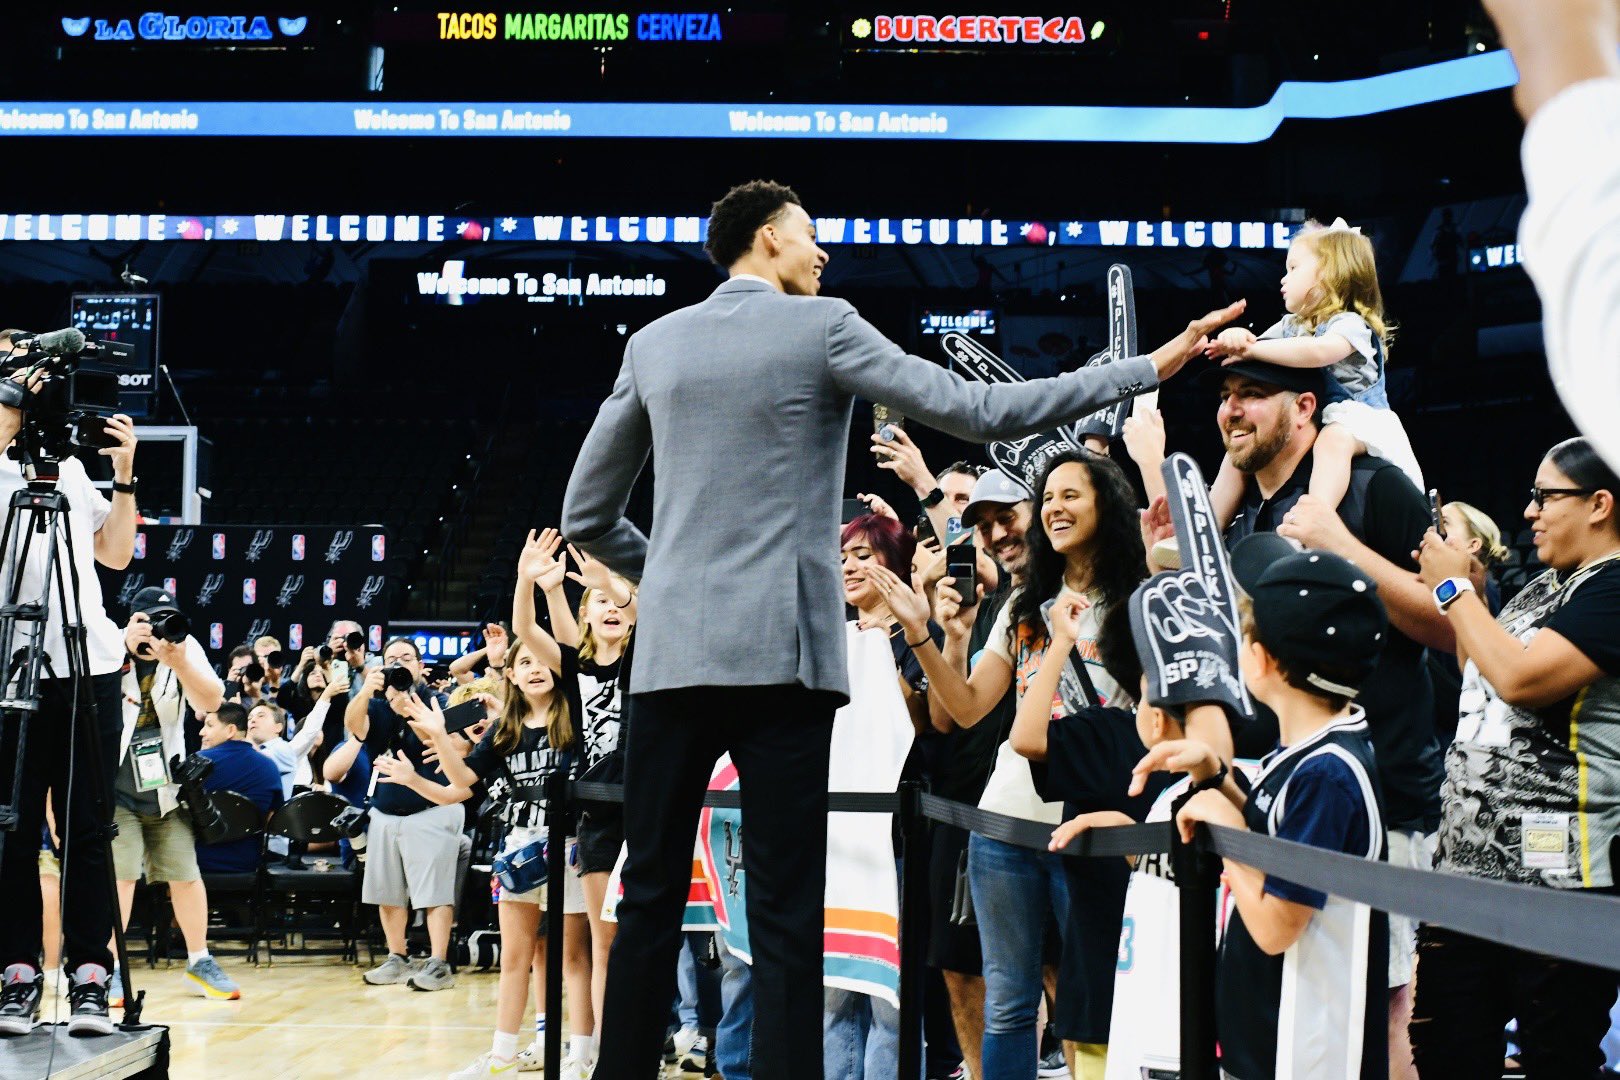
[1411,439,1620,1078]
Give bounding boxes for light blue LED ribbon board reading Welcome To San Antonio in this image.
[0,50,1518,144]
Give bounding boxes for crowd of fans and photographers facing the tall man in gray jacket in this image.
[12,210,1594,1080]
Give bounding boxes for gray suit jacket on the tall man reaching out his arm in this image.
[562,279,1158,698]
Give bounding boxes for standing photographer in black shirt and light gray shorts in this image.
[334,637,465,989]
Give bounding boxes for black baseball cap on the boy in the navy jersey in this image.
[1231,533,1390,698]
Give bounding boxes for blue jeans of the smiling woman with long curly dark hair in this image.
[967,832,1069,1080]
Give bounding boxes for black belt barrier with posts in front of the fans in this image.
[531,774,1620,1080]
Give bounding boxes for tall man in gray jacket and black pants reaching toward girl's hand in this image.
[562,181,1243,1080]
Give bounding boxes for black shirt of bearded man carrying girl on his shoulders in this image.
[1226,453,1443,832]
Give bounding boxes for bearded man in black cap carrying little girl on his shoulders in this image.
[1217,359,1455,1062]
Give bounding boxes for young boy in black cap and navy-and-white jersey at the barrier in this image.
[1150,534,1388,1080]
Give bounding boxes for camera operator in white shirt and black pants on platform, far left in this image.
[0,354,136,1035]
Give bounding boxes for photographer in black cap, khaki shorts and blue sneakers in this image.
[110,588,241,1006]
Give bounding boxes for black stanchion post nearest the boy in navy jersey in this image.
[1170,819,1220,1080]
